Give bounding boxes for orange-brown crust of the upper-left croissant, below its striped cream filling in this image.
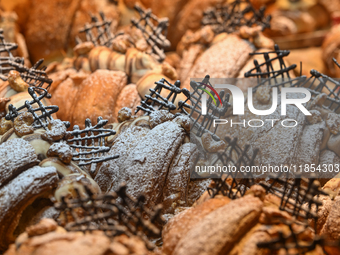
[50,69,140,128]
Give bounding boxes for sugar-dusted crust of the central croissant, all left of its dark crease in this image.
[101,121,185,205]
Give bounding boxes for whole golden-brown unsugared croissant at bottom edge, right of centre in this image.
[162,185,322,255]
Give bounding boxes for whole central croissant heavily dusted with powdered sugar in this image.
[95,110,207,213]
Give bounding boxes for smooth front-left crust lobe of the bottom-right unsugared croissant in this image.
[172,196,263,255]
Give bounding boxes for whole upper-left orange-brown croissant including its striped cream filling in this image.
[50,38,181,127]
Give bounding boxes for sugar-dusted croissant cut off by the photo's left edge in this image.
[0,139,58,250]
